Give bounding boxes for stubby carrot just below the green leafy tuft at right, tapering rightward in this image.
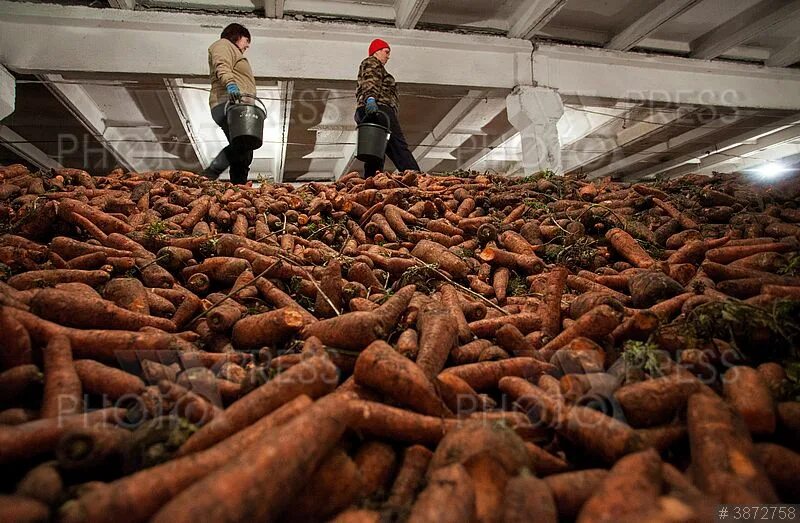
[614,374,703,427]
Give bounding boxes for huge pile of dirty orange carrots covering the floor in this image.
[0,165,800,523]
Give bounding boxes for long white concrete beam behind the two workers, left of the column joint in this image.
[0,1,532,89]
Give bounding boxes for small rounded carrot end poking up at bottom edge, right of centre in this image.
[502,471,558,523]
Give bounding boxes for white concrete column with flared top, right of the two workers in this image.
[506,86,564,175]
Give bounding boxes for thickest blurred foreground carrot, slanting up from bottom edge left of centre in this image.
[152,395,347,523]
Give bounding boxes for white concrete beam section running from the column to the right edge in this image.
[533,44,800,110]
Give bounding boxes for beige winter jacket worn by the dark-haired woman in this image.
[208,38,256,107]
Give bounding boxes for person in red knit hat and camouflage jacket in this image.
[355,38,420,178]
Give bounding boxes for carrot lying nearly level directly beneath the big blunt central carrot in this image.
[348,400,454,445]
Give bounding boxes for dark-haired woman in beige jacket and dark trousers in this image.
[203,24,256,184]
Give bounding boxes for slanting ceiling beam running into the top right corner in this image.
[690,0,800,60]
